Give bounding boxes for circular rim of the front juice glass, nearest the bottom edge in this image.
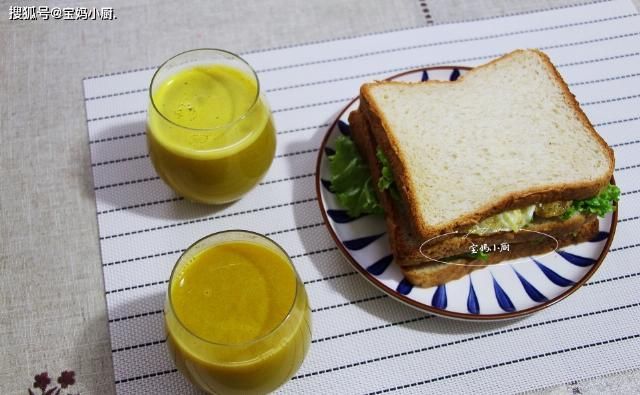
[165,229,301,347]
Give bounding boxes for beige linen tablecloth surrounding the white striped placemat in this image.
[0,0,640,394]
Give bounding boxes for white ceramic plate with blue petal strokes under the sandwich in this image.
[316,67,617,320]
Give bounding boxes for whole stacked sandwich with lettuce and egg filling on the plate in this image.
[330,50,620,287]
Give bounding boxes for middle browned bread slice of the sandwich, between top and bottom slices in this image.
[349,111,593,266]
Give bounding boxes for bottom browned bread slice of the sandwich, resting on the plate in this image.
[401,218,598,287]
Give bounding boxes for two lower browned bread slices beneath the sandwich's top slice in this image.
[349,110,598,287]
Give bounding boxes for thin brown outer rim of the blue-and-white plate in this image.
[315,66,618,321]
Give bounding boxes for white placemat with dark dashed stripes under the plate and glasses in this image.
[84,1,640,394]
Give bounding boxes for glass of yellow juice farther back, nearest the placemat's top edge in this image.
[147,49,276,204]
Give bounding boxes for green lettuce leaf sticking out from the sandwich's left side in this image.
[329,136,383,218]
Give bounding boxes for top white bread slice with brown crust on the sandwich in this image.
[360,50,614,240]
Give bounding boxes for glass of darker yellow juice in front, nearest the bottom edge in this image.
[164,230,311,394]
